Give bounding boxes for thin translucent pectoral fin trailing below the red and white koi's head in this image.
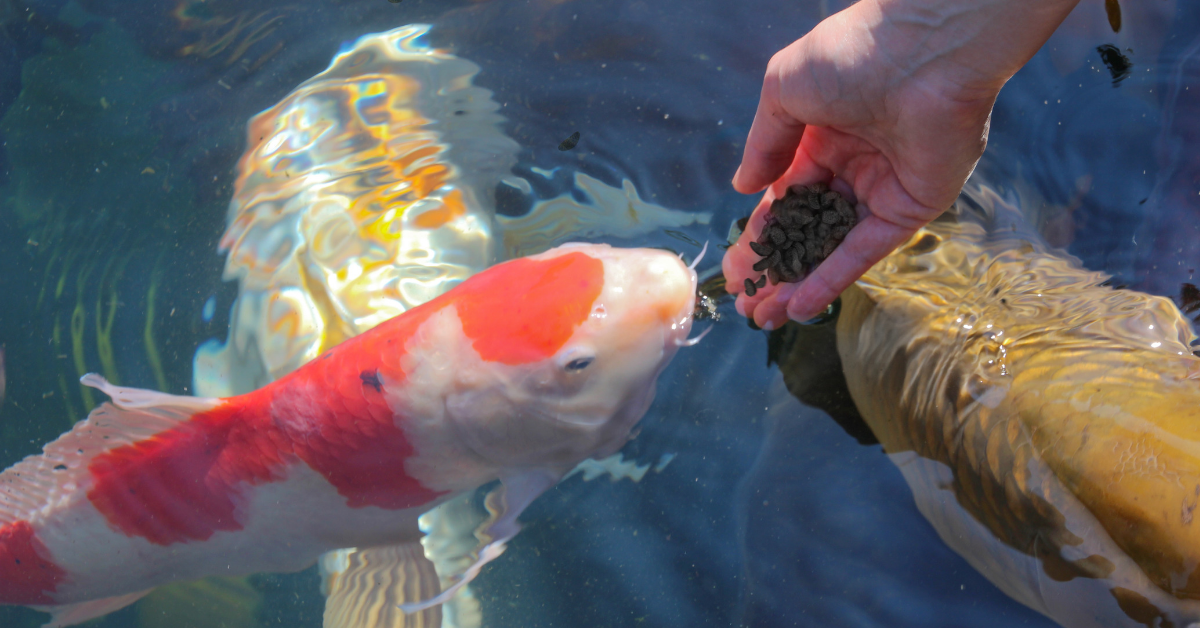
[398,469,562,614]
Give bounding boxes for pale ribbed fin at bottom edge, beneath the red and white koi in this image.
[320,542,442,628]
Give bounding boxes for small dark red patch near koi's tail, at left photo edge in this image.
[0,521,67,604]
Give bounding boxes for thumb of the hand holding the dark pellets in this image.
[733,60,804,195]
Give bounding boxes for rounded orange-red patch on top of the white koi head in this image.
[455,252,604,364]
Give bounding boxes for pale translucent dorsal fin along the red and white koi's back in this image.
[0,373,221,527]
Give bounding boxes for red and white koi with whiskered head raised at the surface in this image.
[0,244,696,626]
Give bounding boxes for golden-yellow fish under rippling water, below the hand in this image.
[838,208,1200,627]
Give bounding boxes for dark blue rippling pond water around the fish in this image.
[0,0,1200,628]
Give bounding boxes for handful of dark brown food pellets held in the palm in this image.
[745,183,858,297]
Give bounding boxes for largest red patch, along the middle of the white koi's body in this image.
[88,303,444,545]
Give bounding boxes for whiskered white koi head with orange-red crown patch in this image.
[432,244,696,471]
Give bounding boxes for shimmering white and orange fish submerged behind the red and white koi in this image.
[193,24,709,396]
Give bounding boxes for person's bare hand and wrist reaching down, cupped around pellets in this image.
[722,0,1098,329]
